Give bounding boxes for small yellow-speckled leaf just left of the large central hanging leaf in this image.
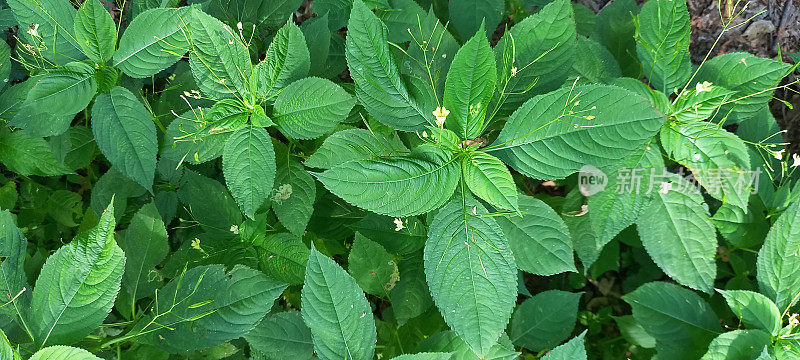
[347,233,400,297]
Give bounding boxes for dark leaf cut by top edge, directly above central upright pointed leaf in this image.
[448,0,506,40]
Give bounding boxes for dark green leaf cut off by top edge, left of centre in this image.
[208,0,303,26]
